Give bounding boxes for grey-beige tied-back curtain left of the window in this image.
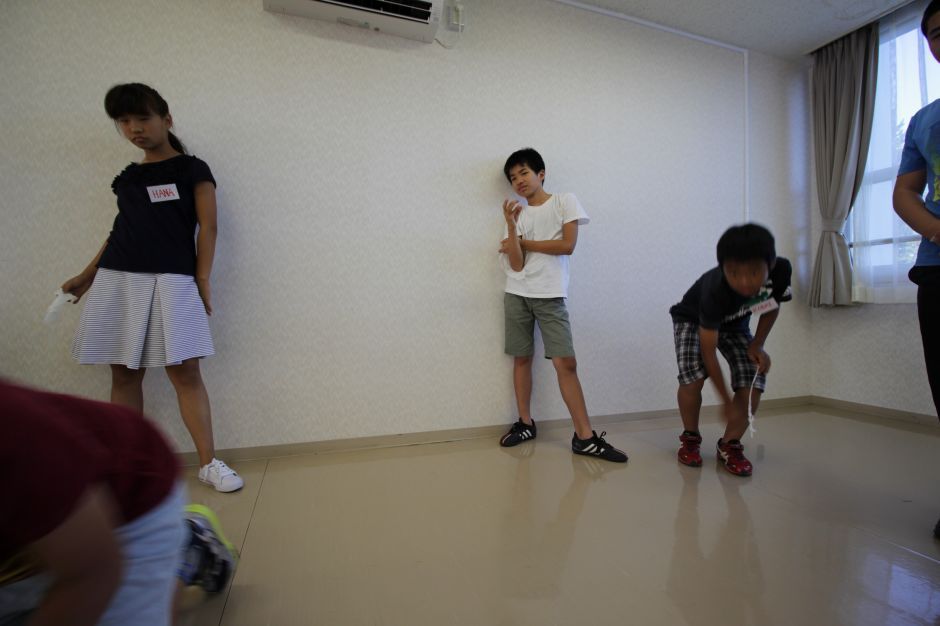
[809,24,890,307]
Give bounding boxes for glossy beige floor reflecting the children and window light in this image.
[181,408,940,626]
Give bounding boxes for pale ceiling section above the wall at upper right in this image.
[559,0,911,59]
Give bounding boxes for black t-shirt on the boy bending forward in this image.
[669,257,793,330]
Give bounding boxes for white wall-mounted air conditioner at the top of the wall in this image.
[263,0,444,43]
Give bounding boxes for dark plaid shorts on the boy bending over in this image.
[672,322,767,391]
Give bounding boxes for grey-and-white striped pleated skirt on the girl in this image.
[72,268,215,369]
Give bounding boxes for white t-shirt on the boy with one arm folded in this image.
[499,193,591,298]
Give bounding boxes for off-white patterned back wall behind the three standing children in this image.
[0,0,810,450]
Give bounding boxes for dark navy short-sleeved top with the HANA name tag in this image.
[98,154,215,276]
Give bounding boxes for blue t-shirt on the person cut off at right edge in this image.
[898,100,940,265]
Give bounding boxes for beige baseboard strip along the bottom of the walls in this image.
[179,396,937,466]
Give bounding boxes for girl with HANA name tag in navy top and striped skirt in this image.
[62,83,244,492]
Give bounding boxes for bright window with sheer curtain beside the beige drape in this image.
[846,1,940,302]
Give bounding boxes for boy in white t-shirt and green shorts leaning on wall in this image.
[499,148,627,463]
